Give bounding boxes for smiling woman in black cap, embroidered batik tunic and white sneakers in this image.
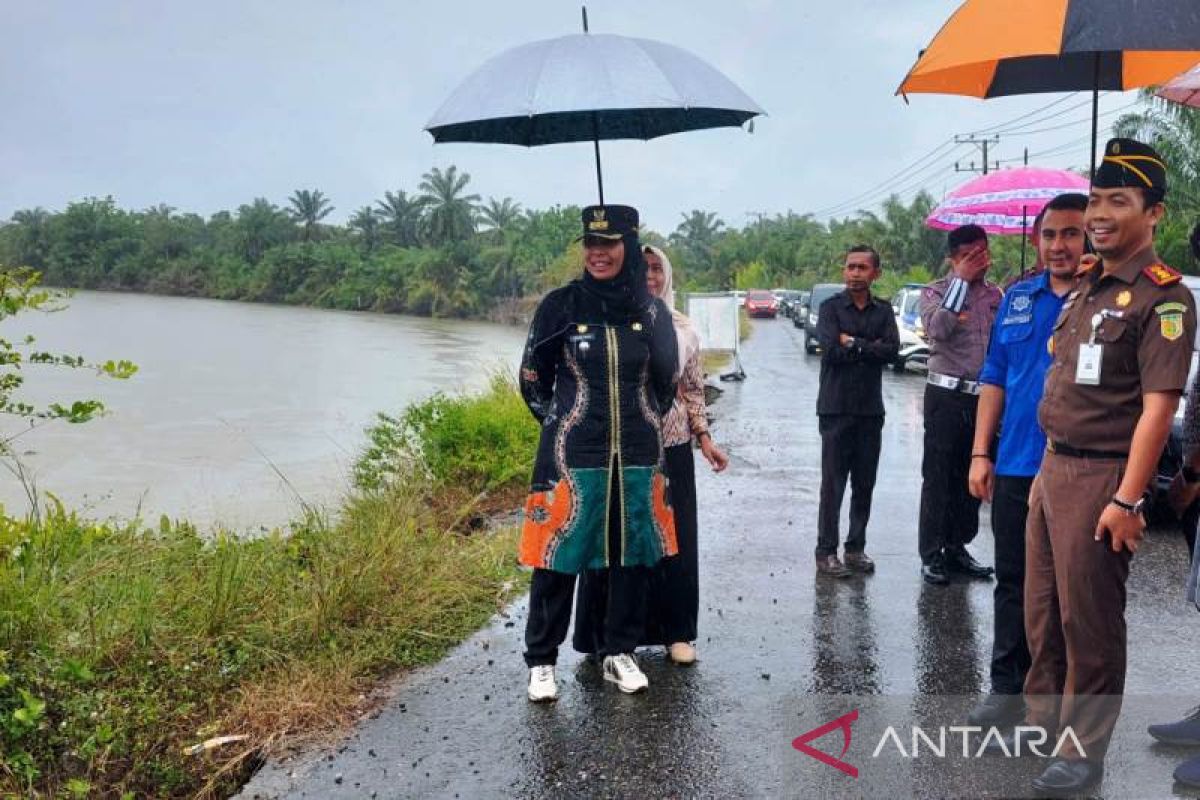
[520,205,678,702]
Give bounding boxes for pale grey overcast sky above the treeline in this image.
[0,0,1135,231]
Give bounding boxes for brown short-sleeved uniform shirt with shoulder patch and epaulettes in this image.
[1038,247,1196,453]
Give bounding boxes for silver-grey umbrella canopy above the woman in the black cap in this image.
[425,34,763,146]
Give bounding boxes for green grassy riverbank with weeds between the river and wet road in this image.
[0,380,538,798]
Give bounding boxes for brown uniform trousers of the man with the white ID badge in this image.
[1025,452,1130,760]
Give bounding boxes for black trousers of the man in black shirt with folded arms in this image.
[816,414,883,558]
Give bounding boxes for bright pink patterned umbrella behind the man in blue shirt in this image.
[925,167,1088,236]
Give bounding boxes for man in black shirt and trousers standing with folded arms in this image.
[816,245,900,578]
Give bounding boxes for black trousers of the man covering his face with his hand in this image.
[917,384,979,564]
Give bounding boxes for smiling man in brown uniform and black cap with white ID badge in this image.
[1025,139,1195,796]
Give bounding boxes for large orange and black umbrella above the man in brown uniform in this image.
[896,0,1200,175]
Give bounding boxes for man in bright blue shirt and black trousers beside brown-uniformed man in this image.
[968,194,1087,727]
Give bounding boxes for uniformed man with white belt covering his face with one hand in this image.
[918,225,1001,585]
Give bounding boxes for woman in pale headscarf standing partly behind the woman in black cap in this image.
[574,246,728,664]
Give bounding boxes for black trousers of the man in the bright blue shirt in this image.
[991,475,1033,694]
